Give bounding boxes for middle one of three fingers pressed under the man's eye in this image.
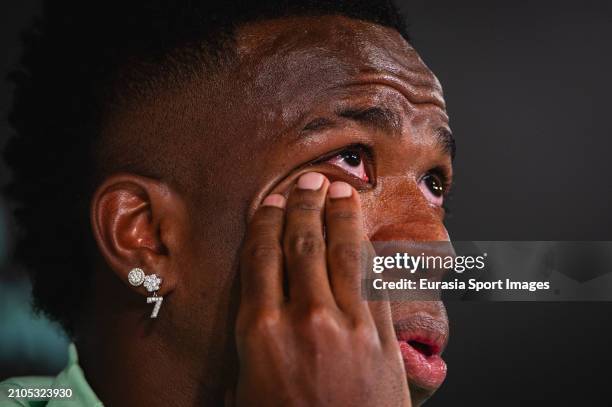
[283,172,333,305]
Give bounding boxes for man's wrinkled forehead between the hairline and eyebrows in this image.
[237,16,444,126]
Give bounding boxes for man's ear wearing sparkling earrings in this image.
[91,174,186,296]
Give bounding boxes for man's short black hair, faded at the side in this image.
[5,0,408,336]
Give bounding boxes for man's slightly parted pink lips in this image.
[394,313,448,390]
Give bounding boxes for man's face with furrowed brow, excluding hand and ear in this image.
[122,16,452,401]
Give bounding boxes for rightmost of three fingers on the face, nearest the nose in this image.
[325,182,367,317]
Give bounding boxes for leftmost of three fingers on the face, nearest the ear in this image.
[240,194,286,307]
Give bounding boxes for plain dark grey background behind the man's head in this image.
[0,0,612,406]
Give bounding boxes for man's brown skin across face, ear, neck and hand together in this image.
[77,16,452,406]
